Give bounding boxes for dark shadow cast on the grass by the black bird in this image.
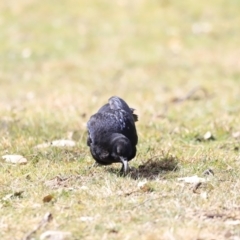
[108,154,179,180]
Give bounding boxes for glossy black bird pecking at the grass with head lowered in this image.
[87,96,138,175]
